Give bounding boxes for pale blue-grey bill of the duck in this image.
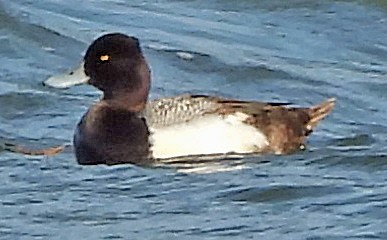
[43,62,89,88]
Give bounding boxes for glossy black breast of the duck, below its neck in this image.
[74,108,151,165]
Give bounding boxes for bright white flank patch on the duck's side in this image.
[150,113,268,159]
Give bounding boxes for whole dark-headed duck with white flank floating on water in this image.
[44,33,336,165]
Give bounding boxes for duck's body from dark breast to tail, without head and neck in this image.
[74,95,334,165]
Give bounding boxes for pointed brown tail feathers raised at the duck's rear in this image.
[306,98,336,130]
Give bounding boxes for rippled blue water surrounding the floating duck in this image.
[0,0,387,239]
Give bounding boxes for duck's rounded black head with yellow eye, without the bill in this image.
[84,33,150,100]
